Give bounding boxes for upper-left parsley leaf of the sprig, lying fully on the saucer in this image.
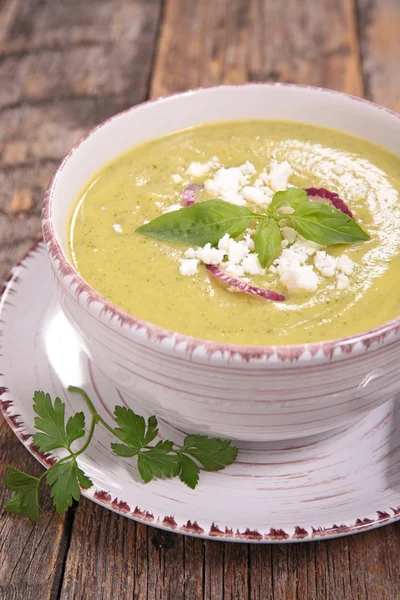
[33,392,85,452]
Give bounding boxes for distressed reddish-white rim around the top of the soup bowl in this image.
[42,82,400,361]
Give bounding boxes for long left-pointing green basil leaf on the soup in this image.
[136,200,254,246]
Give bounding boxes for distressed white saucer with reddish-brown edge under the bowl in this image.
[0,243,400,543]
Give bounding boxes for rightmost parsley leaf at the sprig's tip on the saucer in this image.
[181,434,238,471]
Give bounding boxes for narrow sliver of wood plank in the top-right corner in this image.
[357,0,400,112]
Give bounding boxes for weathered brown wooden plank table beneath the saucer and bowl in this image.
[0,0,400,600]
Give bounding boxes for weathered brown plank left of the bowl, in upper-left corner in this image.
[0,0,161,279]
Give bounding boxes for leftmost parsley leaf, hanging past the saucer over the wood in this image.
[4,465,40,521]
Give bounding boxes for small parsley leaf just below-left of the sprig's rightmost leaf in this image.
[138,440,180,483]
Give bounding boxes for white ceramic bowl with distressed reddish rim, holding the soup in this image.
[43,84,400,441]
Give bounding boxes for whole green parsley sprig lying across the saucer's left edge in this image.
[4,386,237,521]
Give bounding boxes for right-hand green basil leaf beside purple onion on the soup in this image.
[284,202,370,246]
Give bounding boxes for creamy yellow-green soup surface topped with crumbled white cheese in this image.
[70,120,400,345]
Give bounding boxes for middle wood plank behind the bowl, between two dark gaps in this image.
[152,0,363,96]
